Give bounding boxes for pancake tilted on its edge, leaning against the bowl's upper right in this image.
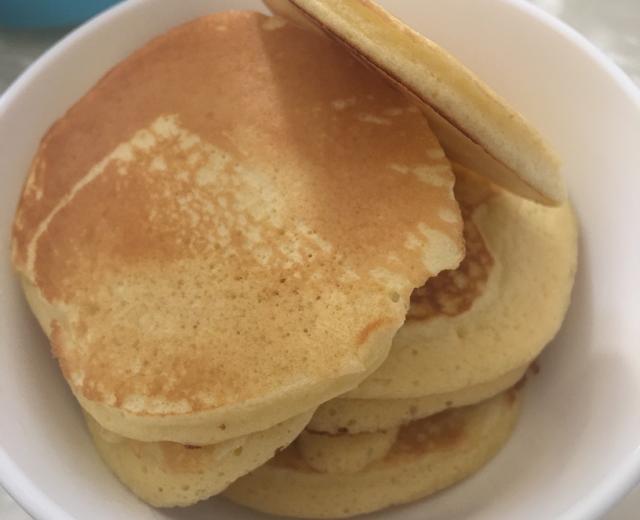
[265,0,566,205]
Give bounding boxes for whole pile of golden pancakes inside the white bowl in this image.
[13,1,576,517]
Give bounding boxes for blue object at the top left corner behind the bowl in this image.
[0,0,119,28]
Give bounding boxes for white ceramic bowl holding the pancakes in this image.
[0,0,640,520]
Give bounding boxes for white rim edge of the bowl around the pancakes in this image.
[0,0,640,520]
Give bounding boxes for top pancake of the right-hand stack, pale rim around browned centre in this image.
[342,167,577,399]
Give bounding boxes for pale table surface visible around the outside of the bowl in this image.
[0,0,640,520]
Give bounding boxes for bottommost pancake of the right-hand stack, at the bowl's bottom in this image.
[224,390,519,518]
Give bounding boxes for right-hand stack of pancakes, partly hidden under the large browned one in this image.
[226,166,576,518]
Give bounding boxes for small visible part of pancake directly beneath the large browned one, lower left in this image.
[85,412,311,507]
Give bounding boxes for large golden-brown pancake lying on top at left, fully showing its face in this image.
[13,12,463,445]
